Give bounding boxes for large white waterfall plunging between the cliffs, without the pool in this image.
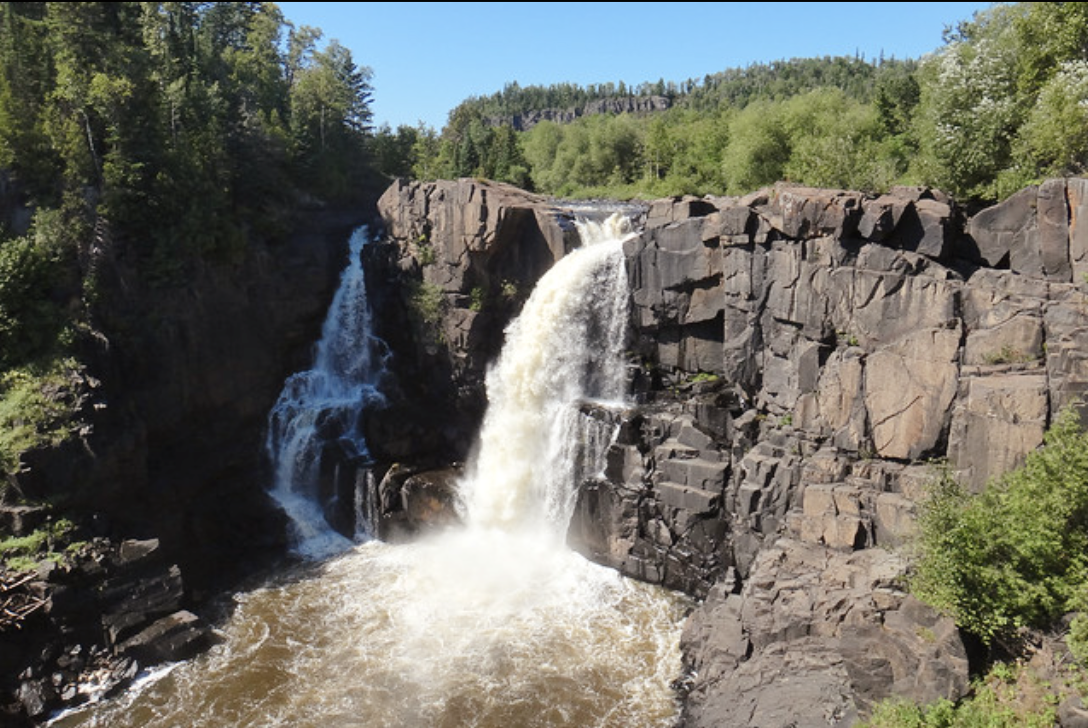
[461,213,632,538]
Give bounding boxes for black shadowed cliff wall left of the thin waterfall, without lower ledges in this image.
[12,205,367,591]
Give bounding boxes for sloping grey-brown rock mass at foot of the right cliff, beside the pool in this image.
[682,539,968,728]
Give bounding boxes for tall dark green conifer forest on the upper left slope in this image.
[0,2,371,272]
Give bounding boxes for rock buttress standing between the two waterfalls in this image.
[364,181,596,462]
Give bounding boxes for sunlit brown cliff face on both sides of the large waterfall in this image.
[375,180,1088,726]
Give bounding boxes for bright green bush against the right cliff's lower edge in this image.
[912,407,1088,642]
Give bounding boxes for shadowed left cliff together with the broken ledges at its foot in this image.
[0,205,369,725]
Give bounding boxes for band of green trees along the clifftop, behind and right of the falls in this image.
[374,2,1088,202]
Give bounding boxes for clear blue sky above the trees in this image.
[277,2,992,131]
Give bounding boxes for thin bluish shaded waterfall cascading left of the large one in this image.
[267,227,387,558]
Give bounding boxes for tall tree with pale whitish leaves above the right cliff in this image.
[913,2,1088,200]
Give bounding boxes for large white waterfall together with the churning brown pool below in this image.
[59,213,688,728]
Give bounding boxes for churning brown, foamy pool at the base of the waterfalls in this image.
[52,531,689,728]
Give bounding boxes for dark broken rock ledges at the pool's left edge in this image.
[0,540,214,725]
